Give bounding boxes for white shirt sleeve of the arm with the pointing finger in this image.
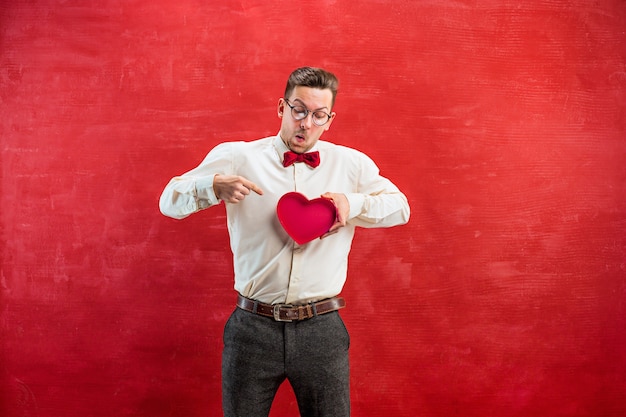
[159,142,233,219]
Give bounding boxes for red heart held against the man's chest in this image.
[276,192,337,245]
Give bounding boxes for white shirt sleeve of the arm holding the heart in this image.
[346,153,411,228]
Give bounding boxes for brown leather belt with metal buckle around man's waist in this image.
[237,295,346,322]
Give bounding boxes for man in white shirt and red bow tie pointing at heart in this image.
[160,67,410,417]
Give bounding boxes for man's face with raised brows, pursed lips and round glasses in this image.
[278,86,335,153]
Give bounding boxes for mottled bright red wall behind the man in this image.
[0,0,626,417]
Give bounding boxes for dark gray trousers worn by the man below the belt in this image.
[222,308,350,417]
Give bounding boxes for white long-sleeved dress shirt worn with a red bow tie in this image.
[159,135,410,304]
